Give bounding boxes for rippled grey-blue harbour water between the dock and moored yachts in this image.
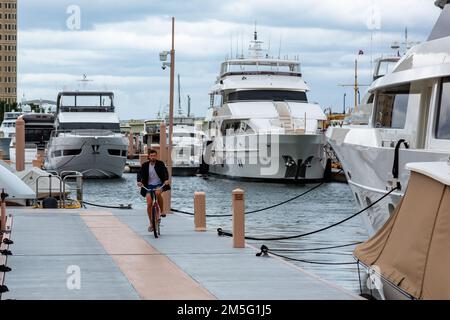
[84,174,367,293]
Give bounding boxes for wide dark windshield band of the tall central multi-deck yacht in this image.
[225,90,308,102]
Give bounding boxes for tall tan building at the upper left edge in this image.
[0,0,17,103]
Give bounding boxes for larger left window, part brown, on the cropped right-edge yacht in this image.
[376,85,410,129]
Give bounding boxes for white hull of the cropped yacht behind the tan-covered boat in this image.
[329,139,448,236]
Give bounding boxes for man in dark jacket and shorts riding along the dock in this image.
[137,150,170,232]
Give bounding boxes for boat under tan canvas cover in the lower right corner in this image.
[354,160,450,300]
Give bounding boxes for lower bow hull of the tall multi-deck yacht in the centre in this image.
[205,134,326,182]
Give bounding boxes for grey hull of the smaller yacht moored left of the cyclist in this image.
[45,135,128,179]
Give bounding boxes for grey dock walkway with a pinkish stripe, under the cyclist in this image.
[1,208,360,300]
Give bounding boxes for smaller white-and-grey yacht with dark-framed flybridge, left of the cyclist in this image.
[45,92,128,178]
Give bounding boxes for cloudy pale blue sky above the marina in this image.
[18,0,440,119]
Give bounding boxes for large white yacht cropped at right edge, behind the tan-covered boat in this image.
[327,0,450,235]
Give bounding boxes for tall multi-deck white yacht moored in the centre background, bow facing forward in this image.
[205,32,327,182]
